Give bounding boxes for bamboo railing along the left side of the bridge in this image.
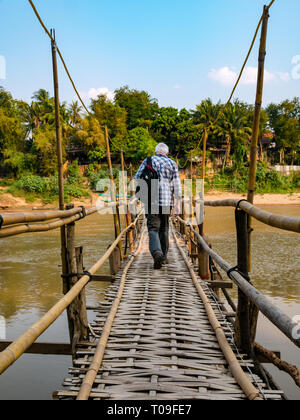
[0,200,143,375]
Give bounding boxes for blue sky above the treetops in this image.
[0,0,300,109]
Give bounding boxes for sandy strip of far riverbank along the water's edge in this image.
[0,188,300,213]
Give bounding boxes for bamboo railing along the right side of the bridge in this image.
[173,200,300,347]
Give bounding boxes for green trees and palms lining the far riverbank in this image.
[0,86,300,202]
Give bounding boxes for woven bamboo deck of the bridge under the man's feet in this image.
[54,226,283,400]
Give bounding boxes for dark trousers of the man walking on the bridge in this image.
[147,208,171,258]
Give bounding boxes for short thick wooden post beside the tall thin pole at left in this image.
[67,204,89,355]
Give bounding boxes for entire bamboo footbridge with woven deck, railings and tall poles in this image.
[0,0,300,400]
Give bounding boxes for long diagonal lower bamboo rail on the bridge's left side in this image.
[0,214,140,375]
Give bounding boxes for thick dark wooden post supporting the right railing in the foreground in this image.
[235,209,255,355]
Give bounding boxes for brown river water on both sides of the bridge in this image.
[0,205,300,400]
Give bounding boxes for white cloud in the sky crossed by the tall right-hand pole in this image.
[208,66,290,86]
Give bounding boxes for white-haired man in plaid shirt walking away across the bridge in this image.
[135,143,182,270]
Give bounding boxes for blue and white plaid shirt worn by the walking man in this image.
[134,155,182,207]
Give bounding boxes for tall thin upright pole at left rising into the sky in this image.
[51,30,69,294]
